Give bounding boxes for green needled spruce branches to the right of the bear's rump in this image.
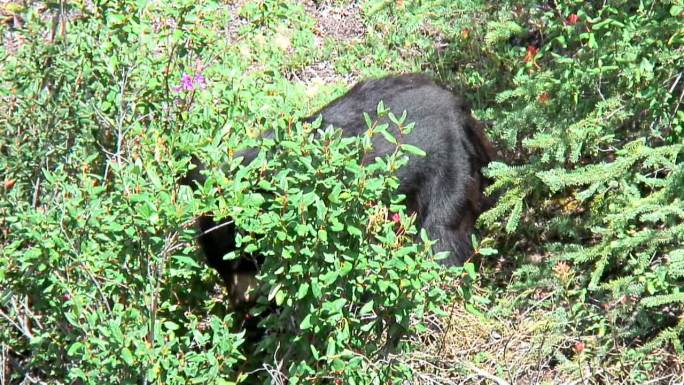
[414,1,684,370]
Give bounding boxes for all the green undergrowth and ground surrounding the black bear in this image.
[0,0,684,384]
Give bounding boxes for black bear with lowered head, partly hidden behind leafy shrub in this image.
[186,74,494,305]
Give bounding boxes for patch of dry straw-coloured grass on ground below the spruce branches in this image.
[402,303,684,385]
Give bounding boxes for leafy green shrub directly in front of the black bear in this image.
[190,105,452,384]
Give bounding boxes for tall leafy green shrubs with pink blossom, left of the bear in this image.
[0,1,251,384]
